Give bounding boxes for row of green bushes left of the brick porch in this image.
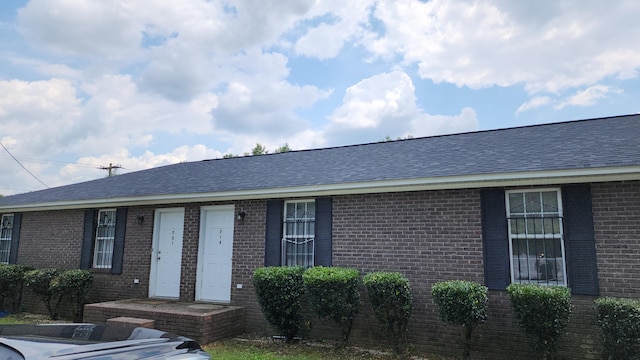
[0,264,93,322]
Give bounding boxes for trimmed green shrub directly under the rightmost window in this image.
[507,284,571,359]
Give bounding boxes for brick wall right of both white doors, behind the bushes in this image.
[233,186,640,359]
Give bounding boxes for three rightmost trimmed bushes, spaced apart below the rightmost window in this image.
[431,280,640,360]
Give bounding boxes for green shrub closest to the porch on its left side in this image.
[51,269,93,322]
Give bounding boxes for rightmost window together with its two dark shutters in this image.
[480,185,598,296]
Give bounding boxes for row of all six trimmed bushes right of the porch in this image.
[253,267,640,359]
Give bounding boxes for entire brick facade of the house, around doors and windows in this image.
[6,181,640,359]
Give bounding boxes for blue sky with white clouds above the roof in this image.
[0,0,640,195]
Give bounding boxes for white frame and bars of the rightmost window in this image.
[505,188,567,286]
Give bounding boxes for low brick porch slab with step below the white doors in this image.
[83,299,245,344]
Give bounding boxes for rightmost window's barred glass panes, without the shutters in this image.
[507,189,567,286]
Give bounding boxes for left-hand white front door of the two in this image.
[149,208,184,299]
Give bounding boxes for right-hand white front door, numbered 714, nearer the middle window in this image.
[196,205,234,303]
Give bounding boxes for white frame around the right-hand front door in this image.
[196,205,235,303]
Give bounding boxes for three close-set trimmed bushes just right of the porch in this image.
[253,266,412,352]
